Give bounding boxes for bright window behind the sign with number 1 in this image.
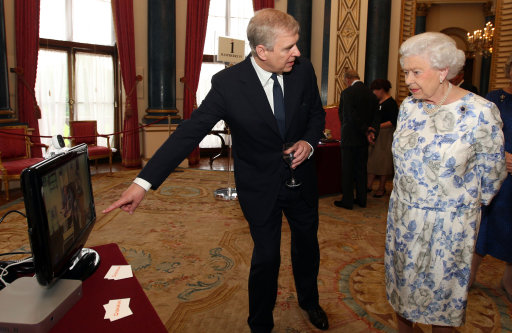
[196,0,254,148]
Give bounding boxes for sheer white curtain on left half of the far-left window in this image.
[35,49,69,145]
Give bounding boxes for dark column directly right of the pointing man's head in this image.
[286,0,313,59]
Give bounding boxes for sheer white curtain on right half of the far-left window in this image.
[74,53,114,146]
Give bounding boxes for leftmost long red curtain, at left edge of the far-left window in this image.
[14,0,42,157]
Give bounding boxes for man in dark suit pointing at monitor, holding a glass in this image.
[104,9,329,333]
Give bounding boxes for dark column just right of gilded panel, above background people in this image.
[364,0,391,86]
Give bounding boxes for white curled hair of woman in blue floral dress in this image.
[400,32,466,80]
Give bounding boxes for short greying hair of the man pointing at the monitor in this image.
[247,8,299,56]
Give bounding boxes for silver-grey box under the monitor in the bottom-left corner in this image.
[0,277,82,333]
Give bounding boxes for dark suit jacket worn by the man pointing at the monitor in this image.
[139,57,325,223]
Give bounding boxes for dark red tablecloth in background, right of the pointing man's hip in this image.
[315,142,341,195]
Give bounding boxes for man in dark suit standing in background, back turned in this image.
[334,69,379,209]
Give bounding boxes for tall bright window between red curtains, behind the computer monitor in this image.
[35,0,119,146]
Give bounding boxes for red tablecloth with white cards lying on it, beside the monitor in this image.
[51,244,167,333]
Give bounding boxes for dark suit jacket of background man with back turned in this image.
[338,81,379,147]
